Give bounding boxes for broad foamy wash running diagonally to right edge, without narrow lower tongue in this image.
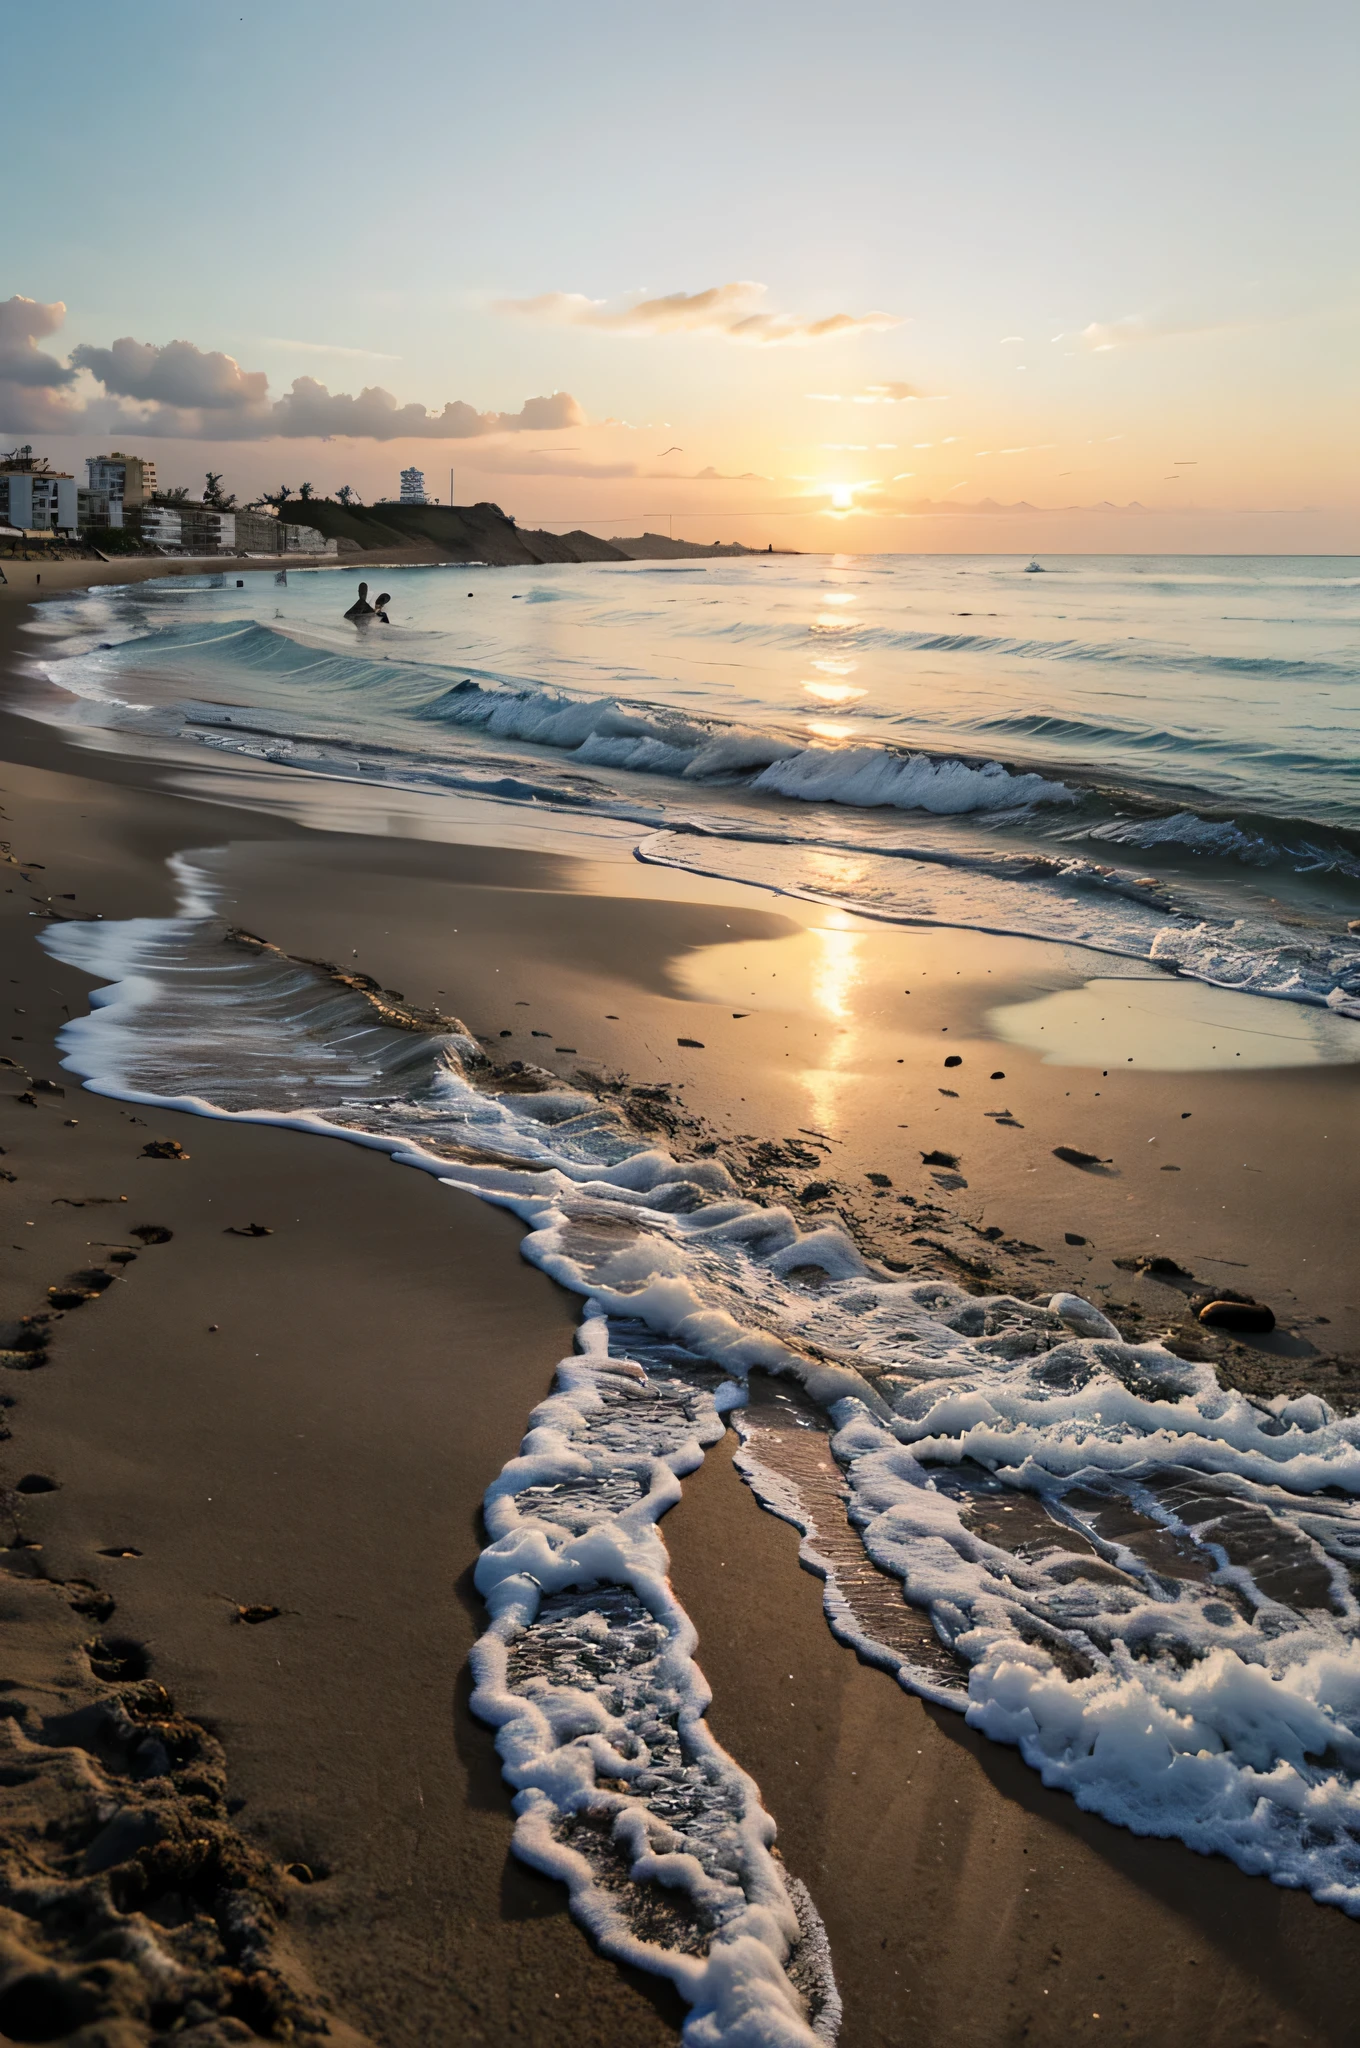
[31,877,1360,1916]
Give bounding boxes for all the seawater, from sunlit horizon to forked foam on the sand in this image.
[15,557,1360,2042]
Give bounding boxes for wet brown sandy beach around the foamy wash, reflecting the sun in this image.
[0,581,1360,2048]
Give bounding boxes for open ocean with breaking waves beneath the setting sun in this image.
[26,555,1360,1014]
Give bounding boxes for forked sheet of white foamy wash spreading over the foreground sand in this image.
[31,851,1360,1966]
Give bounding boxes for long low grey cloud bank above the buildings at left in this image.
[0,297,586,440]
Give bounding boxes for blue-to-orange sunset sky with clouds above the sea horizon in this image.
[0,0,1360,553]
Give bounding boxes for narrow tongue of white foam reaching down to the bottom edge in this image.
[471,1303,840,2048]
